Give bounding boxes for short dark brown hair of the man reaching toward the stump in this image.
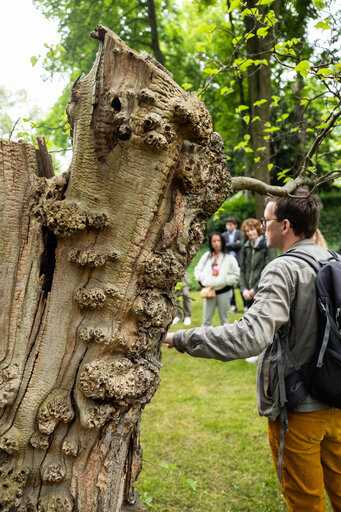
[267,187,322,238]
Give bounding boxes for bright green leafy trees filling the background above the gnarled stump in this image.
[3,0,341,208]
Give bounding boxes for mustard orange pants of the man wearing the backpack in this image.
[268,408,341,512]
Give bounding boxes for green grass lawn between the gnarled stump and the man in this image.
[137,292,287,512]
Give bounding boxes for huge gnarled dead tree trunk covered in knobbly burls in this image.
[0,26,231,512]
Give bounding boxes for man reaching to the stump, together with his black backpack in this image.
[164,187,341,512]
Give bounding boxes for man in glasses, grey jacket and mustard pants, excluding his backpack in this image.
[165,187,341,512]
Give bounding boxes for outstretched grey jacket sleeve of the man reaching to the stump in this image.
[173,260,295,361]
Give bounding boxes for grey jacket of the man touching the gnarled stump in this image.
[173,240,331,419]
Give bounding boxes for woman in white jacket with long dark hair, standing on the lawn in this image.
[194,232,240,325]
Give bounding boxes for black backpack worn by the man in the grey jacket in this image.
[274,251,341,482]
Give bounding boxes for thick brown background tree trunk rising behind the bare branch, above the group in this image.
[244,0,274,219]
